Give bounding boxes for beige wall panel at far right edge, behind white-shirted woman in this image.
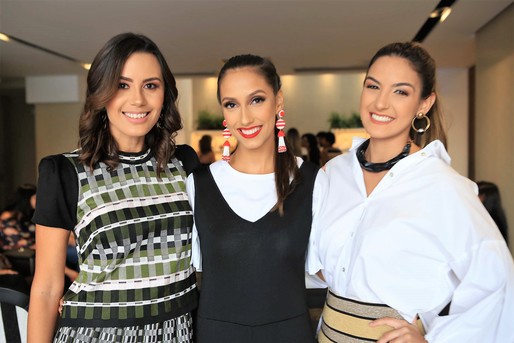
[475,5,514,252]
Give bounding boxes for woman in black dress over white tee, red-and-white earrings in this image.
[187,55,328,343]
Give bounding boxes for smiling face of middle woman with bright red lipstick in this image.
[219,67,283,154]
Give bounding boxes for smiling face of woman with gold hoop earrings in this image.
[360,56,435,146]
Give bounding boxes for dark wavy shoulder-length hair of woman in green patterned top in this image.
[79,33,182,175]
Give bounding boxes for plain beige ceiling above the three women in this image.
[0,0,513,86]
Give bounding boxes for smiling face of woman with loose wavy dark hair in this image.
[105,53,164,152]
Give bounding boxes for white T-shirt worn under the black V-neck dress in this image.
[186,157,328,273]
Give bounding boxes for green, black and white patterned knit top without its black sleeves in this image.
[60,151,196,327]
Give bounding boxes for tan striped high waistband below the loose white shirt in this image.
[318,290,424,343]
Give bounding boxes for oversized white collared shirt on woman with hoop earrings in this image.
[312,140,514,343]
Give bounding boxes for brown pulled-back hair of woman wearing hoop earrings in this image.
[366,42,446,147]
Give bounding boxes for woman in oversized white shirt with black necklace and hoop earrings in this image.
[315,42,514,343]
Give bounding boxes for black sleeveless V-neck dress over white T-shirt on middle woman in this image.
[193,162,319,343]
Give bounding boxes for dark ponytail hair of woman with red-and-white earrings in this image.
[217,54,300,215]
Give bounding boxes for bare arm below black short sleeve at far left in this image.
[28,225,70,343]
